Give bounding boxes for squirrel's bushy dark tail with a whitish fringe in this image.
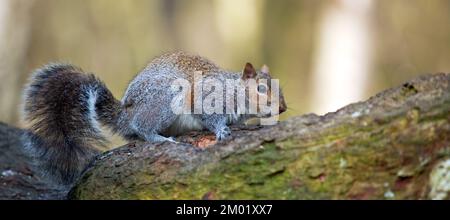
[23,64,120,184]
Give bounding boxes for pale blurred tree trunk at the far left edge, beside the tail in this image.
[0,0,34,123]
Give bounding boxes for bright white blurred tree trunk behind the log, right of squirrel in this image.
[311,0,373,114]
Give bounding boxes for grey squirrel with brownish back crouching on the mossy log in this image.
[23,52,287,184]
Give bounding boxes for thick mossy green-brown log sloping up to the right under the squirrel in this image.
[70,74,450,199]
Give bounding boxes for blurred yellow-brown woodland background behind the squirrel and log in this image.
[0,0,450,125]
